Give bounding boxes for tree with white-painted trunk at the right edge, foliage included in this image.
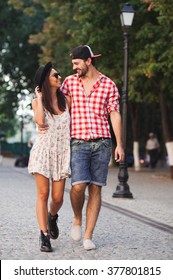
[131,0,173,178]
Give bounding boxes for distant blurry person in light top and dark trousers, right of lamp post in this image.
[146,132,160,168]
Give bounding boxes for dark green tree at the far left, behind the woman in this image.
[0,1,44,135]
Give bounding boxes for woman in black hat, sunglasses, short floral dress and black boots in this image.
[28,62,70,252]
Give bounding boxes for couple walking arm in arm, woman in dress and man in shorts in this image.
[28,45,124,252]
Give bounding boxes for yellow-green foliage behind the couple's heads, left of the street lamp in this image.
[10,0,123,82]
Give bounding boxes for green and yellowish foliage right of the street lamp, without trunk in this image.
[132,0,173,101]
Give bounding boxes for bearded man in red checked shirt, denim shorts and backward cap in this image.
[61,45,124,250]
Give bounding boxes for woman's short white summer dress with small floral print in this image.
[28,108,70,181]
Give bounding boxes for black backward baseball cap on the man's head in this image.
[70,45,101,59]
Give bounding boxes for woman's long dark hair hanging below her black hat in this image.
[41,70,66,115]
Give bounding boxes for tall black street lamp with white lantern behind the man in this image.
[112,3,135,198]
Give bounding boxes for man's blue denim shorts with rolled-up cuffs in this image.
[71,138,112,186]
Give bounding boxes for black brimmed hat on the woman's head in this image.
[34,62,53,89]
